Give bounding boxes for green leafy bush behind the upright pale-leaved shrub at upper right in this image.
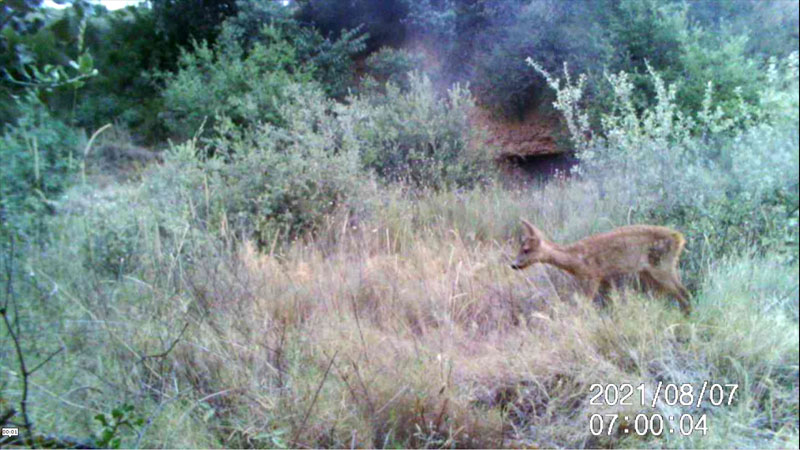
[598,0,765,125]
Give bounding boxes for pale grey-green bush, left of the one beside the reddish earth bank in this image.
[157,84,369,243]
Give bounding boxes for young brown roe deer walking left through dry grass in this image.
[511,219,691,315]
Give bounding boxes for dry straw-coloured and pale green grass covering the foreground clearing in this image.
[6,183,800,447]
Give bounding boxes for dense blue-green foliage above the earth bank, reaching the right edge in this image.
[400,0,800,118]
